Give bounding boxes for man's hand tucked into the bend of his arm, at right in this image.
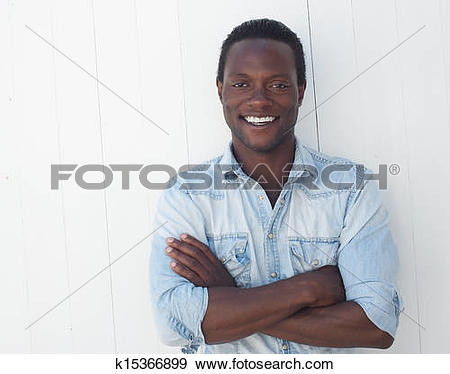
[301,265,346,307]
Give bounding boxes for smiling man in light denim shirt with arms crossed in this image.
[150,19,401,353]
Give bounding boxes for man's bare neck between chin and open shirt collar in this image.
[233,134,295,190]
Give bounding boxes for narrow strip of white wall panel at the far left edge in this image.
[0,1,31,353]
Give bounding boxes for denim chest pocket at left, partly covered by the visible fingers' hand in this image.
[207,233,250,287]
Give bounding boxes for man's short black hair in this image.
[217,18,306,87]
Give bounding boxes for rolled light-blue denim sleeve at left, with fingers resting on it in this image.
[149,180,208,353]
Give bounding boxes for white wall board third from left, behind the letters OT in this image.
[51,0,114,353]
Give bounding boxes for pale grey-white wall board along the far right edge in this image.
[396,0,450,353]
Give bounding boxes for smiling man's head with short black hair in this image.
[216,19,306,152]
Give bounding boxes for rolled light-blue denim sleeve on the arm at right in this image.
[338,169,403,337]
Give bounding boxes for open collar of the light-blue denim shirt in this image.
[219,135,317,180]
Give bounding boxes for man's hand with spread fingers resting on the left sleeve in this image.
[166,234,236,287]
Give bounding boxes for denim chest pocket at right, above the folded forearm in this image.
[289,237,339,274]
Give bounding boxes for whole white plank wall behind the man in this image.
[0,0,450,353]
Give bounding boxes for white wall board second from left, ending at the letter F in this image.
[15,1,73,353]
